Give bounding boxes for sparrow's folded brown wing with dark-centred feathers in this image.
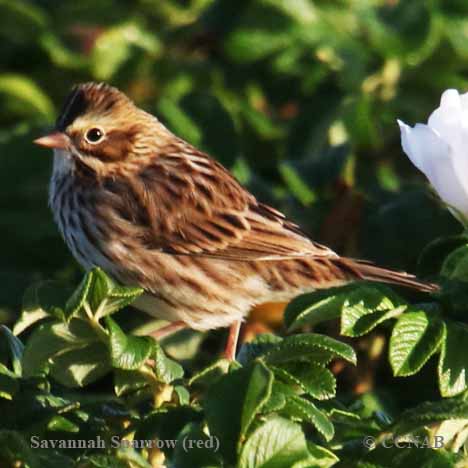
[117,143,336,261]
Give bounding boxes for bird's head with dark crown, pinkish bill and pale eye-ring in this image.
[34,83,169,172]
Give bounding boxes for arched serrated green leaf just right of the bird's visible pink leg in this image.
[264,333,356,364]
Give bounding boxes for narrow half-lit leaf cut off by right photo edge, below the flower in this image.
[438,322,468,397]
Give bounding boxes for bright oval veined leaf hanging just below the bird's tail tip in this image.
[389,310,445,377]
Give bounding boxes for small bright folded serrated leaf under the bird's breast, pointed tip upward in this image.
[105,317,154,370]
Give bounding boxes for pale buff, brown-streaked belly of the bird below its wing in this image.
[103,244,267,330]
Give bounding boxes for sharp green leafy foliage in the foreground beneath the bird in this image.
[0,266,468,467]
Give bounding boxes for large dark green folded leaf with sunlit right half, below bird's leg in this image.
[203,362,273,459]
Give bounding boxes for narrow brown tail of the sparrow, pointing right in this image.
[339,258,440,292]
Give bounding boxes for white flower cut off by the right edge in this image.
[398,89,468,220]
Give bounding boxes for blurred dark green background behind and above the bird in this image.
[0,0,468,322]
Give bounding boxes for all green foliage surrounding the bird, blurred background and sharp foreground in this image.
[0,0,468,468]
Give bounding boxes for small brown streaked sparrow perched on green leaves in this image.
[35,83,436,359]
